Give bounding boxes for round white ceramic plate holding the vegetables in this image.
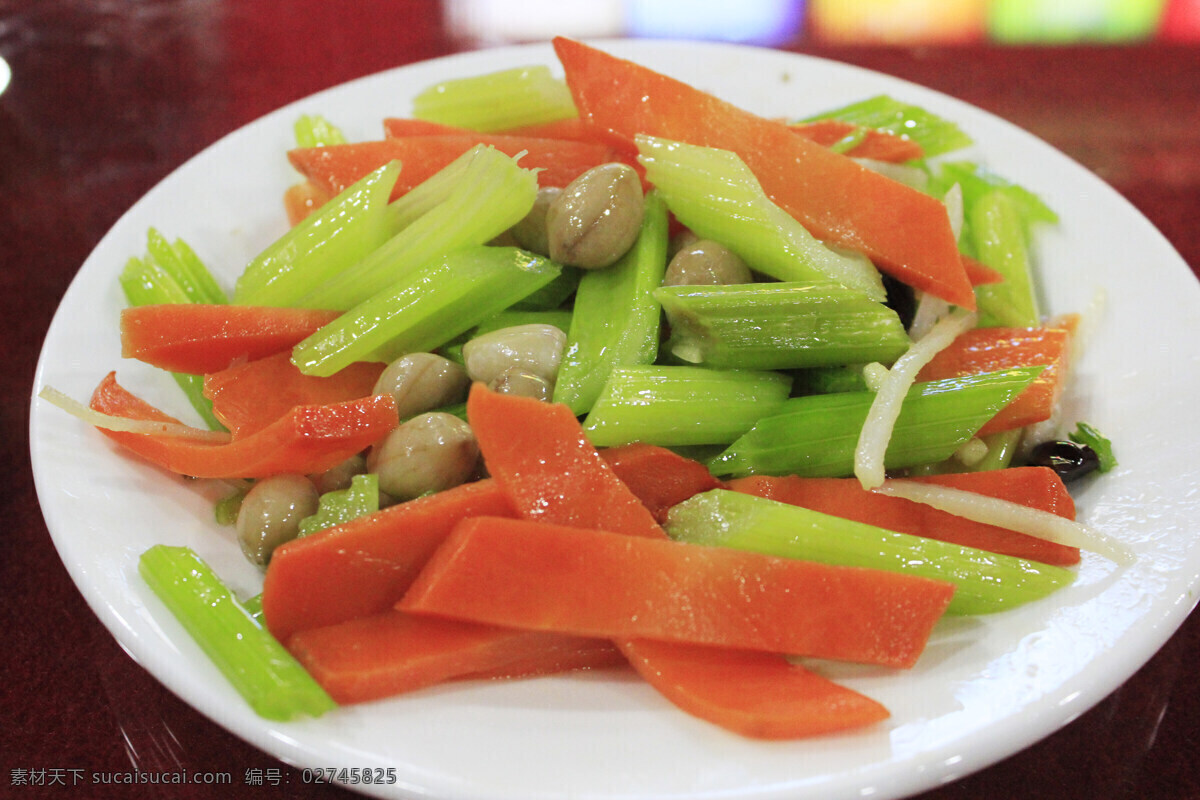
[31,42,1200,800]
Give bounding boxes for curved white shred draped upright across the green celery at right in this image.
[854,308,978,489]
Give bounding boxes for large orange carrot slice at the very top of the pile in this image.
[554,37,976,309]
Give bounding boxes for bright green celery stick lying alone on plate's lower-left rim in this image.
[138,545,336,720]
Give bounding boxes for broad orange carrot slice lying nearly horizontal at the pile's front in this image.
[397,517,954,667]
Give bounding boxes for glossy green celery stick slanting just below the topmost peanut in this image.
[292,245,560,377]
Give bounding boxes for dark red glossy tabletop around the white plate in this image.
[0,0,1200,800]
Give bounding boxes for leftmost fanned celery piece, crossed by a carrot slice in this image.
[118,228,228,431]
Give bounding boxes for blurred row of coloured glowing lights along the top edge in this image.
[444,0,1200,46]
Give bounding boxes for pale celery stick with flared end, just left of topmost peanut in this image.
[301,145,538,311]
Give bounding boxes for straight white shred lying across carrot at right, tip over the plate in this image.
[875,480,1134,566]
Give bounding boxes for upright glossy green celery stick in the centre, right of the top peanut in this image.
[554,190,667,415]
